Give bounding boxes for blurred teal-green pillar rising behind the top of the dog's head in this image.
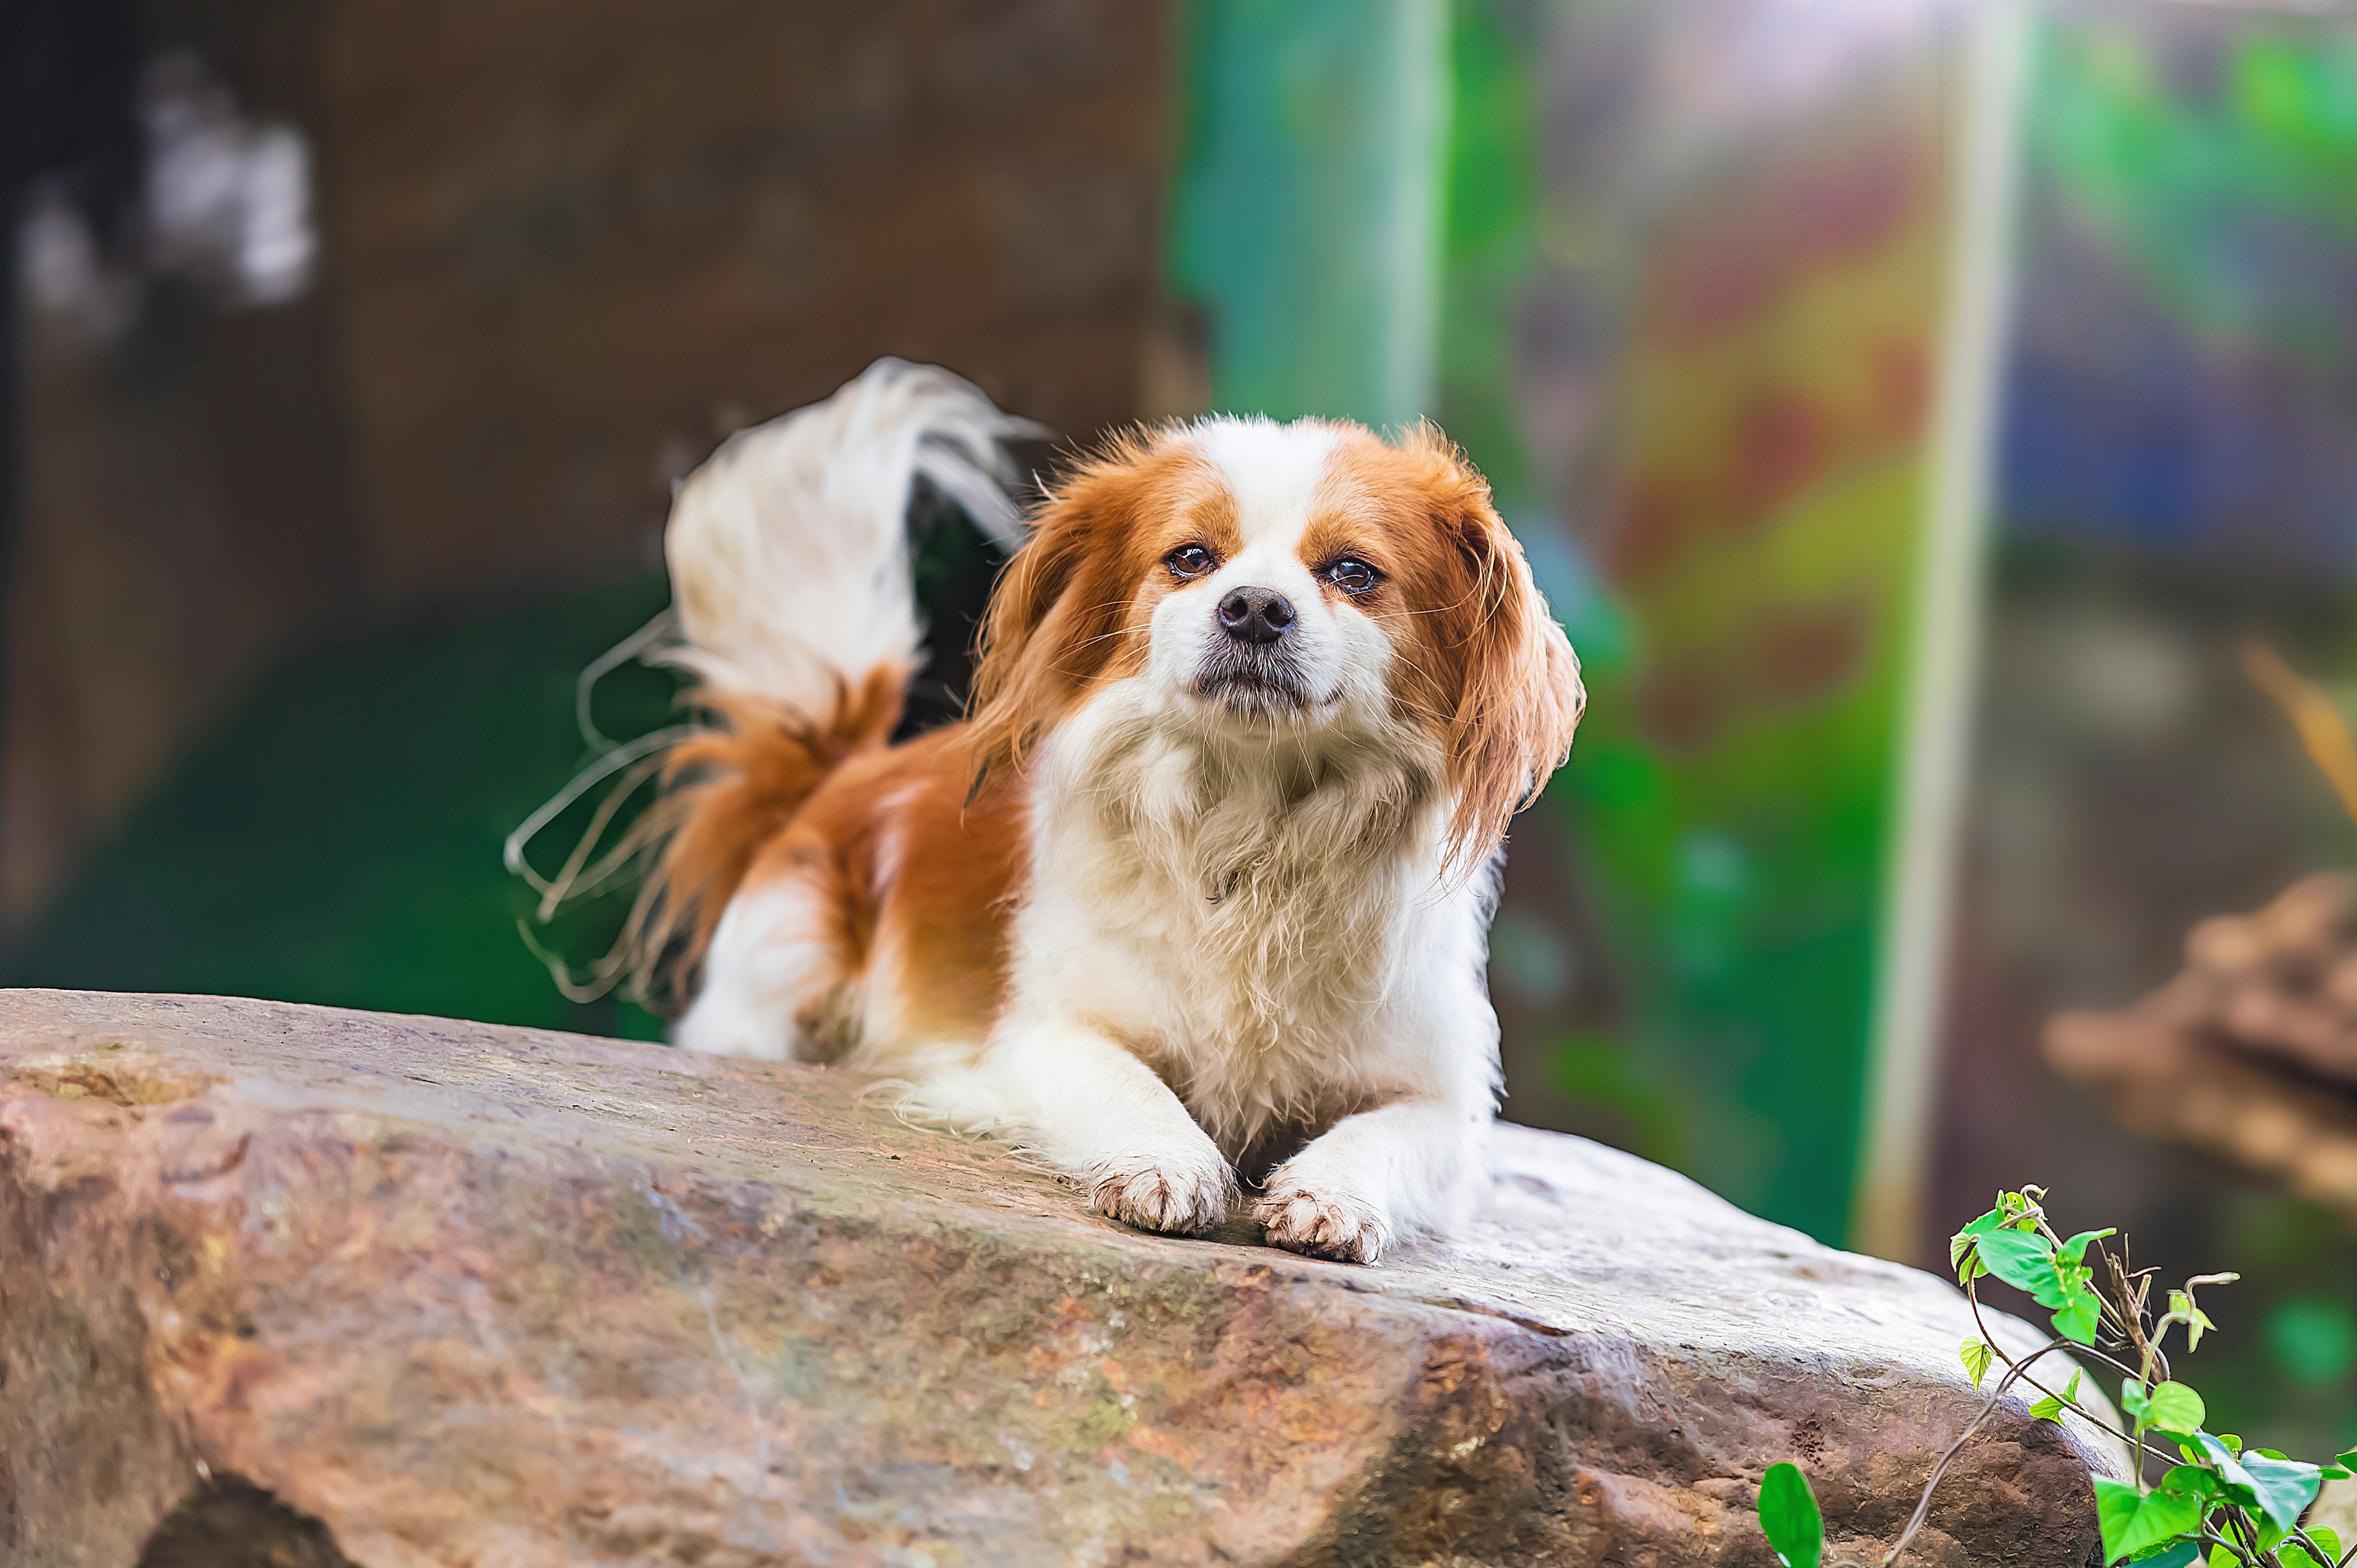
[1169,0,1450,425]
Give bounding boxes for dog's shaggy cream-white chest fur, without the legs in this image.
[1013,686,1485,1146]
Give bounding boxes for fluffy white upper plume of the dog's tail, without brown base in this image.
[662,358,1039,717]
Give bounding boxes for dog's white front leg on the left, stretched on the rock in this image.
[978,1019,1235,1235]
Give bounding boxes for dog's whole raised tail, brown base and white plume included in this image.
[627,358,1039,997]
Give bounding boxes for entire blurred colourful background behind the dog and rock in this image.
[0,0,2357,1453]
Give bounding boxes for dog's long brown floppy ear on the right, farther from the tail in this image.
[1403,425,1589,865]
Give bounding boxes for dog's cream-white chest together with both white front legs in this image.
[945,674,1496,1262]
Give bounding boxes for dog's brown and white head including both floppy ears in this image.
[973,420,1586,859]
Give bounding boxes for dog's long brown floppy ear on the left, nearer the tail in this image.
[969,434,1153,790]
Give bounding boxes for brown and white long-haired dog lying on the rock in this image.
[651,361,1584,1262]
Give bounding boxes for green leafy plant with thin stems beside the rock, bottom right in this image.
[1759,1186,2357,1568]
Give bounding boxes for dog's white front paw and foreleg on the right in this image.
[1252,1094,1492,1264]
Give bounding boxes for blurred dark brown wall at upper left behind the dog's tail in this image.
[0,0,1169,922]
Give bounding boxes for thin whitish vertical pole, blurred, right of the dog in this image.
[1850,0,2027,1259]
